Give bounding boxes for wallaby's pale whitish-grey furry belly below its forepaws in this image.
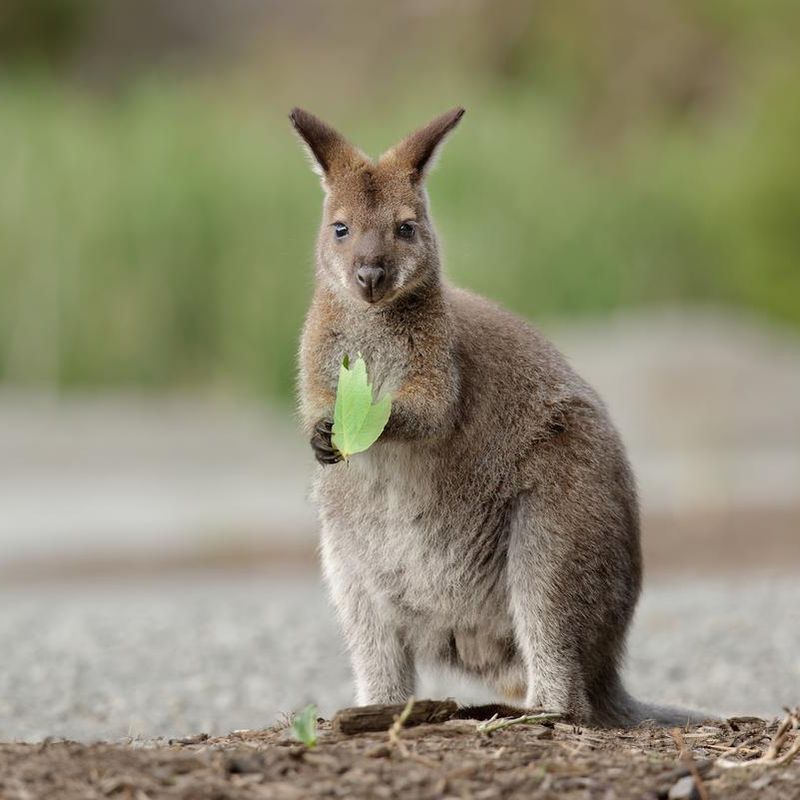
[316,443,512,648]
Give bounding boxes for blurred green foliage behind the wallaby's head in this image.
[0,0,800,400]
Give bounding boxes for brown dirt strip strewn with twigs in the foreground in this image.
[0,715,800,800]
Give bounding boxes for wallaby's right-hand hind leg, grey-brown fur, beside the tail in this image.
[508,465,640,724]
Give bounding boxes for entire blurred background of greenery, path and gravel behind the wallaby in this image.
[0,0,800,739]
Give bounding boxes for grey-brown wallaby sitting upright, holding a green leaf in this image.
[290,108,687,726]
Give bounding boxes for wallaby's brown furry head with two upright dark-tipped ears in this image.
[290,108,464,304]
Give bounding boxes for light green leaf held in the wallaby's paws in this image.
[331,354,392,459]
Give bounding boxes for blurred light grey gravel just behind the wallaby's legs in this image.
[0,574,800,741]
